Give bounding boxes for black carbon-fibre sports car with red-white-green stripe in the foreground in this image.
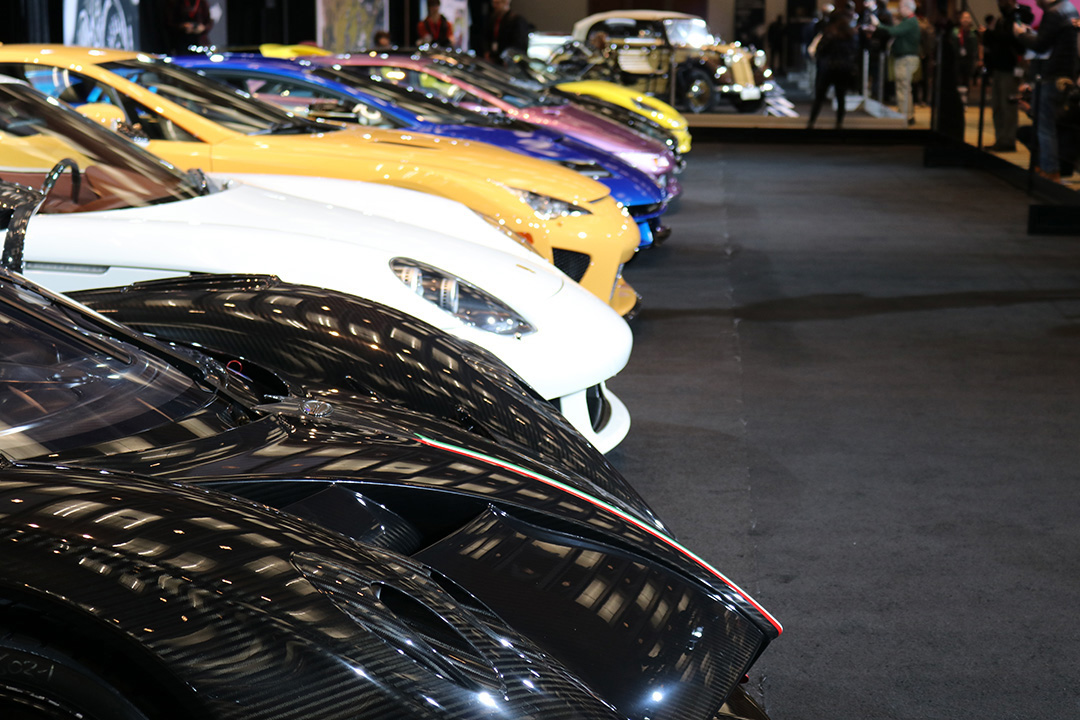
[0,195,782,720]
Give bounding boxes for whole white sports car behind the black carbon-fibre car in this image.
[0,83,632,451]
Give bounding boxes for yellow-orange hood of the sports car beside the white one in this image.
[212,127,609,204]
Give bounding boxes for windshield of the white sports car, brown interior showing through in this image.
[0,83,201,213]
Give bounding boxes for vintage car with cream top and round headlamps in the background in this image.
[572,10,773,112]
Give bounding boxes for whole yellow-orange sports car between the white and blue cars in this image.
[0,45,639,315]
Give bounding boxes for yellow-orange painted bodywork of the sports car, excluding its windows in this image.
[0,45,640,314]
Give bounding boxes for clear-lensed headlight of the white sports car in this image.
[390,258,536,336]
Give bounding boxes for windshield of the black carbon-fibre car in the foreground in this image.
[0,273,232,460]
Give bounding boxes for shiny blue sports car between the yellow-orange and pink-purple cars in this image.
[173,54,672,247]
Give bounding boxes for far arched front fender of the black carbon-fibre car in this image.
[71,275,659,524]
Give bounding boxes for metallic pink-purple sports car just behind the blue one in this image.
[308,53,681,198]
